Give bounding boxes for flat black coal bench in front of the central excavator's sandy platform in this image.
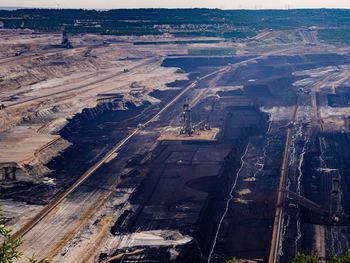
[103,108,267,262]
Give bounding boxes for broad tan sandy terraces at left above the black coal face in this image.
[0,31,194,180]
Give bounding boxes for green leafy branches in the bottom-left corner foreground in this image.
[0,212,49,263]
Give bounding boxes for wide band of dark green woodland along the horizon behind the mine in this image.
[0,9,350,43]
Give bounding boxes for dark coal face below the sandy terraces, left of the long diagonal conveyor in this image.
[0,90,178,204]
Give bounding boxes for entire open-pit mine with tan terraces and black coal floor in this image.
[0,8,350,263]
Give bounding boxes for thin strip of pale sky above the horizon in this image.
[0,0,350,9]
